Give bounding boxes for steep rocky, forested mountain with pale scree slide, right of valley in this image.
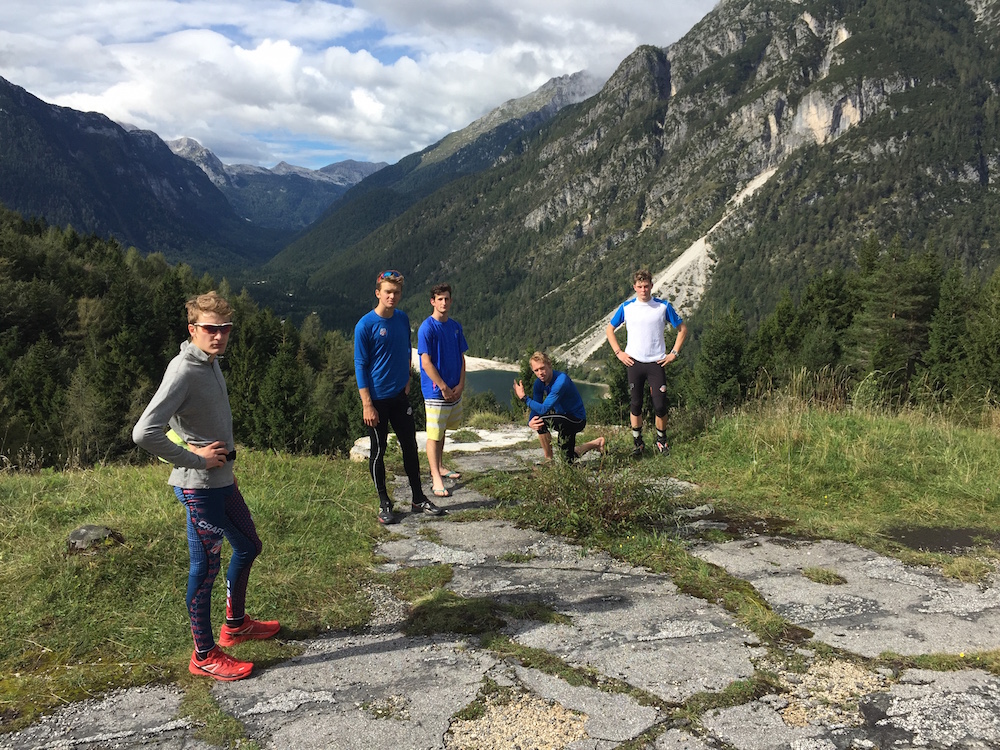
[266,0,1000,357]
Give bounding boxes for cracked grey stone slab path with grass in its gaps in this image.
[0,451,1000,750]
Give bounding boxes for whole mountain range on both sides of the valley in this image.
[0,0,1000,359]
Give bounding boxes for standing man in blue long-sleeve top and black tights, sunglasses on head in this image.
[354,271,444,523]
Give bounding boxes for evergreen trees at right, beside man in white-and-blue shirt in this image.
[652,234,1000,415]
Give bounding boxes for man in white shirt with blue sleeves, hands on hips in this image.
[605,269,687,457]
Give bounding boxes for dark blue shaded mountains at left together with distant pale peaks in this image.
[0,78,385,270]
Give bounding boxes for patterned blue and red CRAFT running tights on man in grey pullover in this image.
[174,483,262,652]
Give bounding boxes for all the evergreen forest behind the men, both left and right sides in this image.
[0,200,1000,469]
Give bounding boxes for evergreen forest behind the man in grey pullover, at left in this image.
[0,209,382,469]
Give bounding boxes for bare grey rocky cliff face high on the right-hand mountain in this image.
[522,2,914,276]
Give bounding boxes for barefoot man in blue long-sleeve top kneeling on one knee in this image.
[514,352,604,463]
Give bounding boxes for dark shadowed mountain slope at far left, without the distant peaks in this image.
[0,79,292,269]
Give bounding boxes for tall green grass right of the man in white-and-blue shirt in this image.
[671,407,1000,549]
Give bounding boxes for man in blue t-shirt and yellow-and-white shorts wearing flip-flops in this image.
[417,284,469,497]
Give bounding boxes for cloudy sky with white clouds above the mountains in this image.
[0,0,716,168]
